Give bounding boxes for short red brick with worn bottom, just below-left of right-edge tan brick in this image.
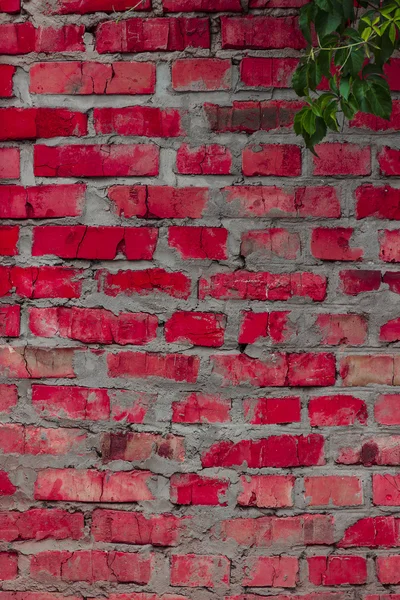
[308,394,368,427]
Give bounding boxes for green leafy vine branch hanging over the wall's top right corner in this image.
[293,0,400,154]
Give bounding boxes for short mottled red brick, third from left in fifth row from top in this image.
[176,144,232,175]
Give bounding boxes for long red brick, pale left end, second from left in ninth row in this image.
[29,307,158,346]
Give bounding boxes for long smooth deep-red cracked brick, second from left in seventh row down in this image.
[32,225,158,260]
